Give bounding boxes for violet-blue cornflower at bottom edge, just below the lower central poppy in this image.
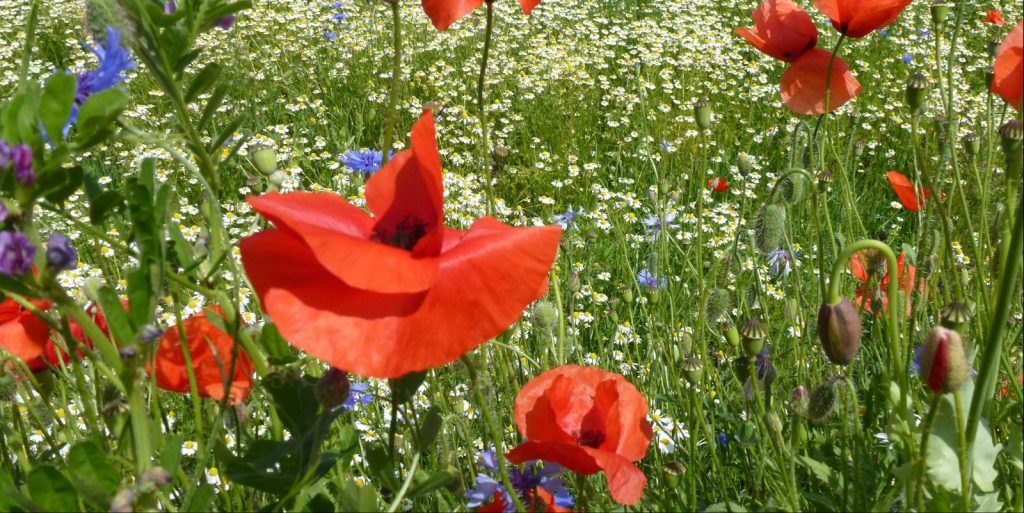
[465,448,573,513]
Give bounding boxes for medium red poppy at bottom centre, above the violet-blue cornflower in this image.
[506,366,652,505]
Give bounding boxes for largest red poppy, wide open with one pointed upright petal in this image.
[241,111,561,378]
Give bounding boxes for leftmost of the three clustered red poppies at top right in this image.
[735,0,818,62]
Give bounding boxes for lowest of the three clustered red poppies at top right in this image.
[779,49,863,115]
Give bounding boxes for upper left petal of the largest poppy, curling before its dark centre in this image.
[249,191,437,293]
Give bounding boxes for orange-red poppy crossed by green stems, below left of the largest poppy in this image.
[154,306,253,404]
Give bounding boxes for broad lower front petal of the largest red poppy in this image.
[241,217,561,378]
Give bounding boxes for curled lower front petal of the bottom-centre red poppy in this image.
[505,441,647,506]
